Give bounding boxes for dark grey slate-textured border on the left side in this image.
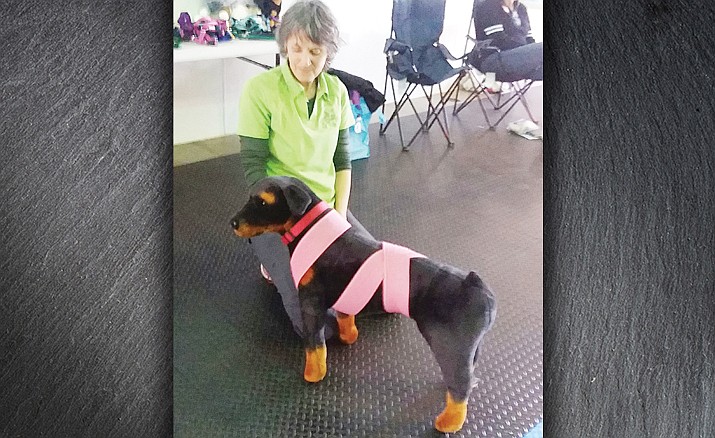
[0,0,172,437]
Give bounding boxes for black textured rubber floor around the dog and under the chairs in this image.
[174,94,543,437]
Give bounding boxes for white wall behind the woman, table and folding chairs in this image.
[174,0,541,144]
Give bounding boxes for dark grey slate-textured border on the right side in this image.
[544,0,715,438]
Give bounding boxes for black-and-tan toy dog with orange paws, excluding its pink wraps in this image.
[231,177,496,432]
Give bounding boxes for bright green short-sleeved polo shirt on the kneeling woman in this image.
[238,63,355,205]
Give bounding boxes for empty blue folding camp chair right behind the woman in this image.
[380,0,467,150]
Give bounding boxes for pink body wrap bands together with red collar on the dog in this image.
[283,202,424,316]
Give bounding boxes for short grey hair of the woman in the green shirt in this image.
[276,0,340,69]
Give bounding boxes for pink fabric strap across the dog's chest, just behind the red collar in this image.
[284,208,351,287]
